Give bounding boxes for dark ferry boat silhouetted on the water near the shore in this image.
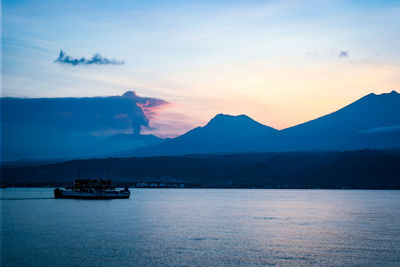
[54,179,131,199]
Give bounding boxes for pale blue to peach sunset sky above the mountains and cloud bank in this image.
[1,0,400,137]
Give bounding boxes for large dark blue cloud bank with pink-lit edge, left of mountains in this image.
[0,91,168,158]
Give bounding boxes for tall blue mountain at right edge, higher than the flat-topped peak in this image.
[257,91,400,151]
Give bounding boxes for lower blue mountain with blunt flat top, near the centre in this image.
[120,114,278,156]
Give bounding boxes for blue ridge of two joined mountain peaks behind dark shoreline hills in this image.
[119,91,400,156]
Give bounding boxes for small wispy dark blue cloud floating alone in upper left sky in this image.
[54,50,125,66]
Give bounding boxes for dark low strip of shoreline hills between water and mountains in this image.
[0,150,400,189]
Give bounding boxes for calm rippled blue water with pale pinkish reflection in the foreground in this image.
[0,188,400,266]
